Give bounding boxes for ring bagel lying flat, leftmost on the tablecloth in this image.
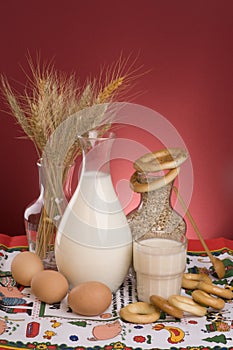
[119,301,160,324]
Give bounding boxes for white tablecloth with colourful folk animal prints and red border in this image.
[0,234,233,350]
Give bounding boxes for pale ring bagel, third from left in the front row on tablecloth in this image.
[168,295,207,316]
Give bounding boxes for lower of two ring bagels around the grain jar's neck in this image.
[130,167,180,193]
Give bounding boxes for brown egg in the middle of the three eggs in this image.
[31,270,69,304]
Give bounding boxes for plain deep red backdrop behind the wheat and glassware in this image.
[0,0,233,238]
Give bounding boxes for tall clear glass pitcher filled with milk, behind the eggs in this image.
[55,131,132,292]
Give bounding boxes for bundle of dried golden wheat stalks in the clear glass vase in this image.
[1,52,143,258]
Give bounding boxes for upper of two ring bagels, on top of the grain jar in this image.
[134,148,188,172]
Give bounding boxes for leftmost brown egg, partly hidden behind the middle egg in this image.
[11,251,44,286]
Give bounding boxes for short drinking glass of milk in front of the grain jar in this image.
[133,233,187,302]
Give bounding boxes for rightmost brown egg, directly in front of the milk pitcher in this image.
[68,281,112,316]
